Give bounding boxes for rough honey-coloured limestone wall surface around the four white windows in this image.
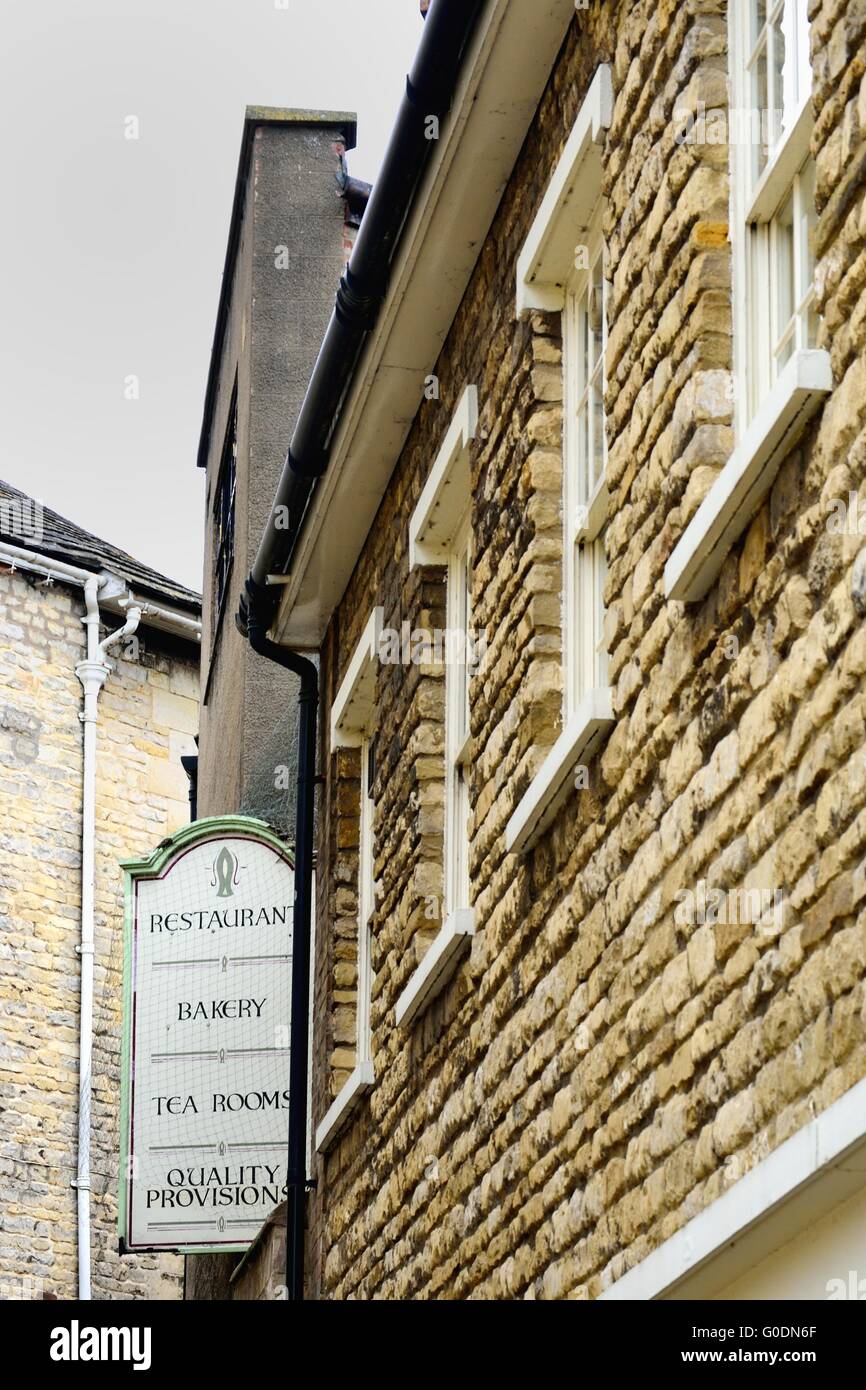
[310,0,866,1298]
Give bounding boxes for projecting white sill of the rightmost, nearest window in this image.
[664,349,833,603]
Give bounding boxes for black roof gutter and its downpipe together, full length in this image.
[235,0,485,1300]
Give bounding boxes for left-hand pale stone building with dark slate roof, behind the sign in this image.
[0,484,200,1300]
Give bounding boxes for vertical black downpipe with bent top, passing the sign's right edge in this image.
[247,614,318,1302]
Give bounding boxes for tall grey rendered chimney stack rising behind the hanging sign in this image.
[197,107,366,837]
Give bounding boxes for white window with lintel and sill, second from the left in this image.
[396,386,478,1027]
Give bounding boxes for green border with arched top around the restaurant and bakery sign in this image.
[117,816,295,1255]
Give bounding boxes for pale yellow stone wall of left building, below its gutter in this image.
[0,570,199,1298]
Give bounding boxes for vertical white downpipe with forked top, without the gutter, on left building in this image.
[75,574,142,1300]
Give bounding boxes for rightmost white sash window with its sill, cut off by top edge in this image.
[664,0,833,603]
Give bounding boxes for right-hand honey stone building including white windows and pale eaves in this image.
[204,0,866,1298]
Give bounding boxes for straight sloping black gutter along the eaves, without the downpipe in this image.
[238,0,484,631]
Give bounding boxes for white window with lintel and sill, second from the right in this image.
[506,64,614,853]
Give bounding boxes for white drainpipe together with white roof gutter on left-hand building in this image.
[0,541,202,1300]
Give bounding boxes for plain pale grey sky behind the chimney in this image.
[0,0,423,588]
